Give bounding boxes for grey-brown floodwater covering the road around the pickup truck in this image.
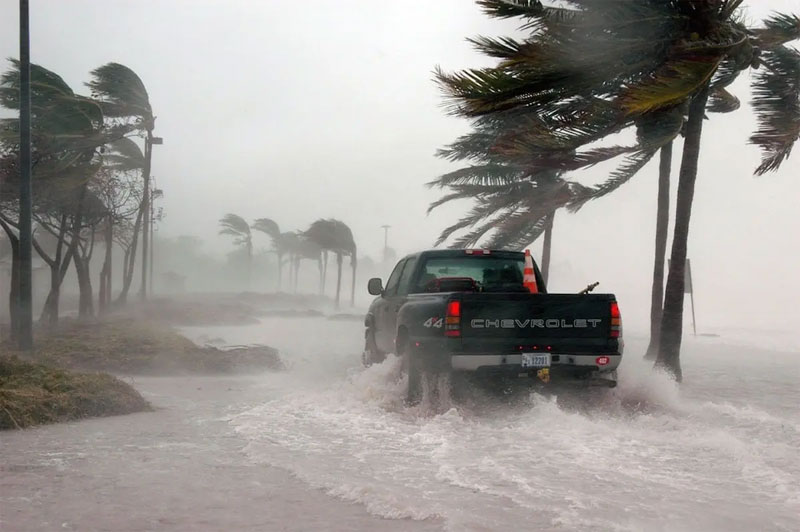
[0,318,800,532]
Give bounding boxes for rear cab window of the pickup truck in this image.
[414,255,527,293]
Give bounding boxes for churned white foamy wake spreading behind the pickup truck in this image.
[231,318,800,531]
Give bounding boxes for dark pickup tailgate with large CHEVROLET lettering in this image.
[460,293,618,352]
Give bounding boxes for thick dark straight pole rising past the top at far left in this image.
[17,0,33,351]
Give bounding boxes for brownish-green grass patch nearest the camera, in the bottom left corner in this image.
[0,356,151,429]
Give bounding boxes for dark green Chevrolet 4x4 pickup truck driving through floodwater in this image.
[363,249,623,401]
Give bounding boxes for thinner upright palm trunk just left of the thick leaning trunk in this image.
[644,141,672,360]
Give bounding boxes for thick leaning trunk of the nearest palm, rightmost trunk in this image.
[656,86,709,382]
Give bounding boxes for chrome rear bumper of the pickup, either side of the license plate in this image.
[450,353,622,375]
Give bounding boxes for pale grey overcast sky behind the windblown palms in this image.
[0,0,800,329]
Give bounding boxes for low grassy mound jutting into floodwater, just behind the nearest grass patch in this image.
[3,318,283,375]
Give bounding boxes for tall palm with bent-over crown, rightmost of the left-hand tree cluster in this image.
[86,63,155,299]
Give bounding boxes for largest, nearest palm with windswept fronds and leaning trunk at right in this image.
[438,0,800,379]
